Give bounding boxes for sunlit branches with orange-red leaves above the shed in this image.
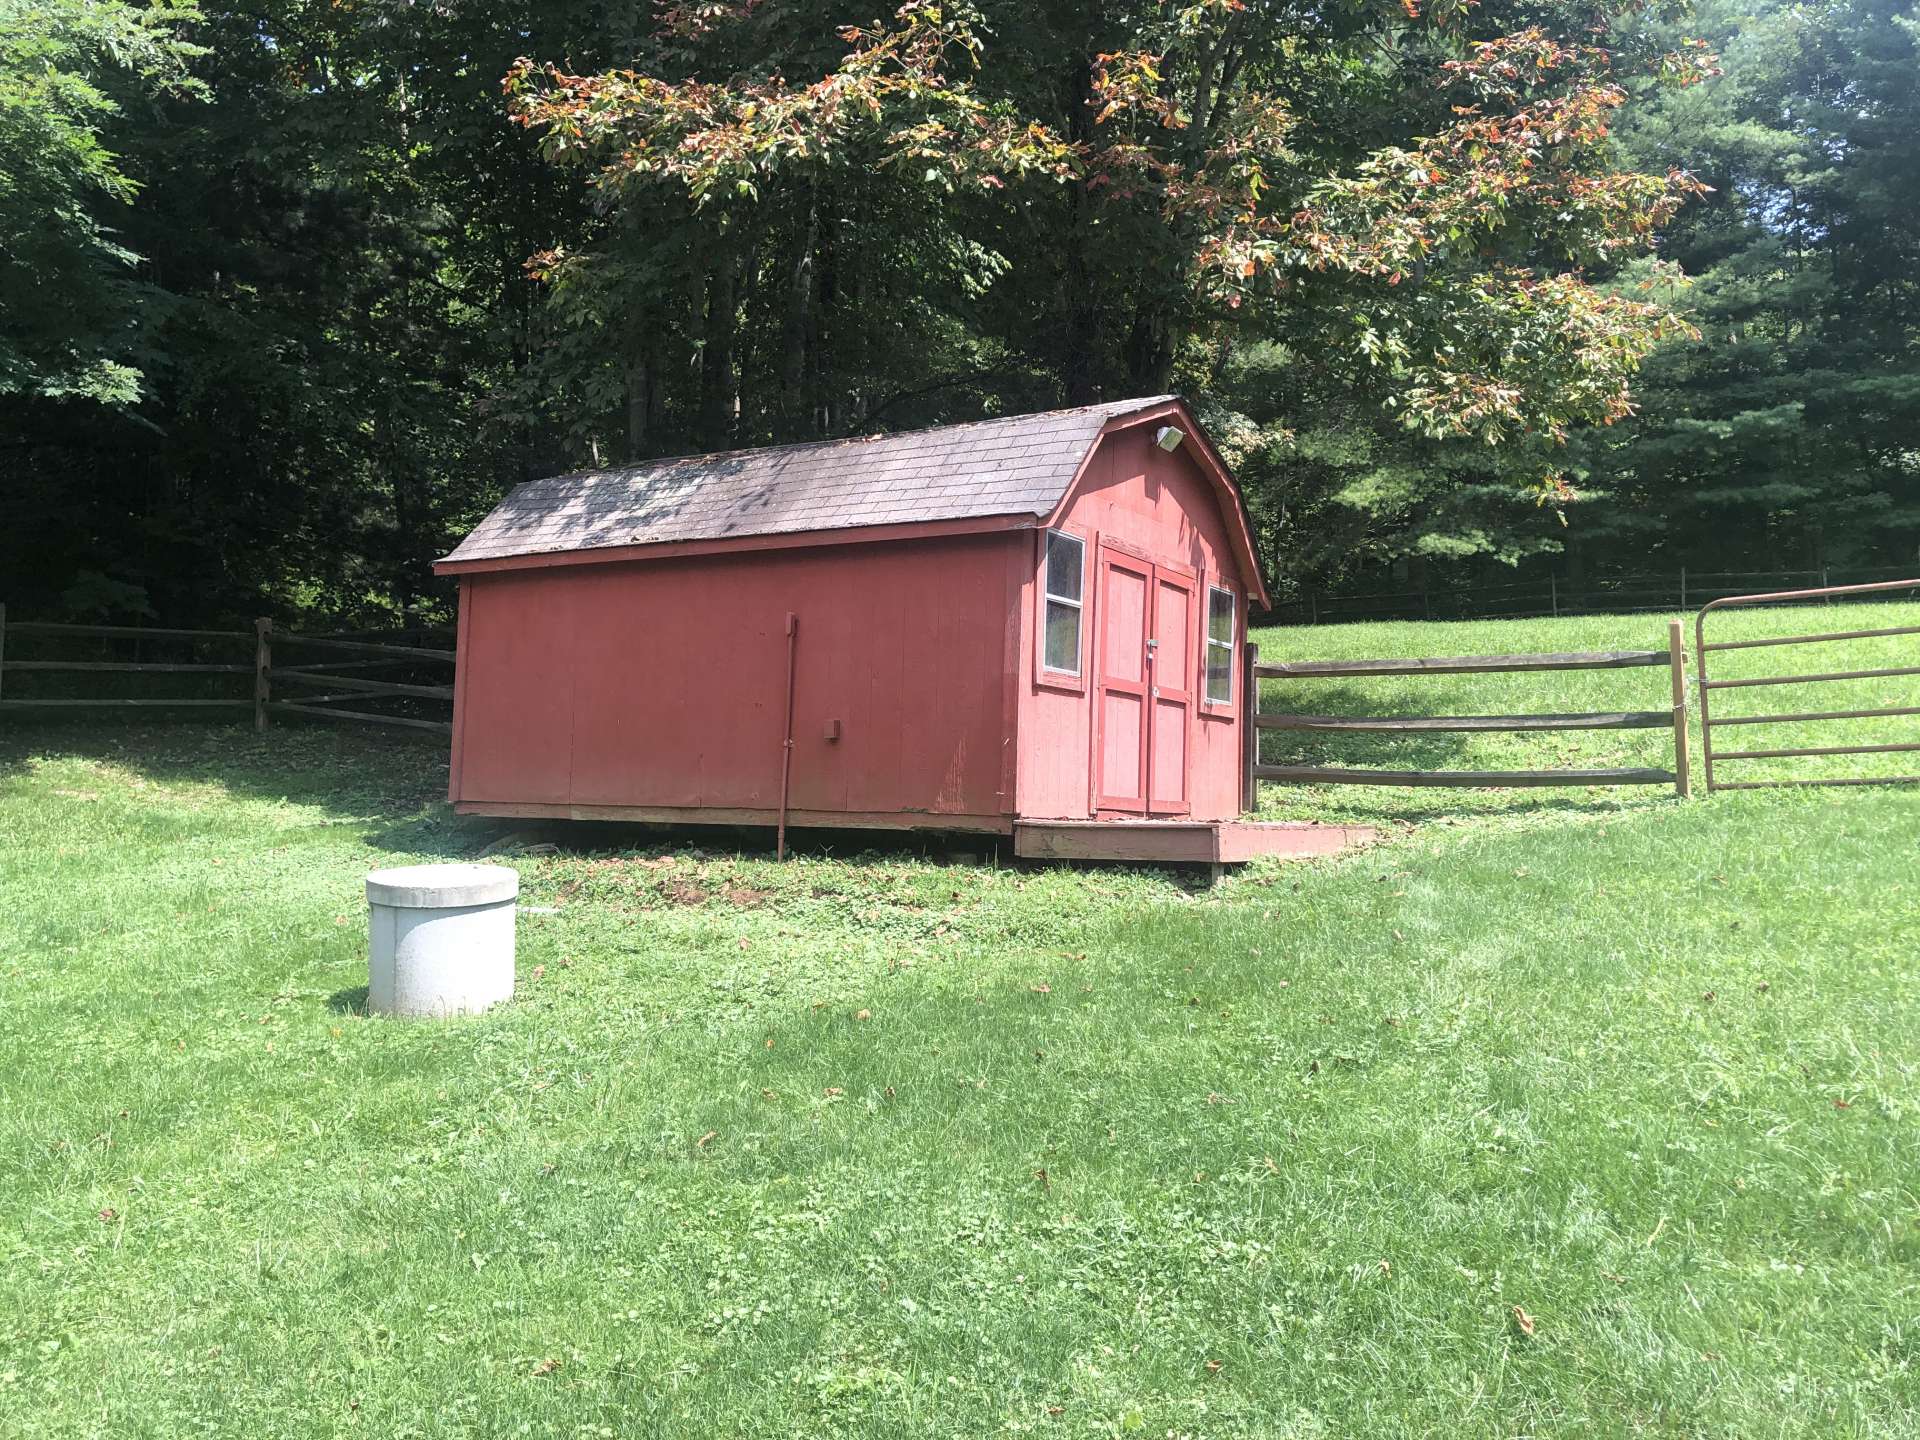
[505,0,1715,462]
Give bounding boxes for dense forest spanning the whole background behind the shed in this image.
[0,0,1920,624]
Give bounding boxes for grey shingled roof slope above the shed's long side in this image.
[445,396,1173,561]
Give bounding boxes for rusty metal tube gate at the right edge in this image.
[1693,580,1920,795]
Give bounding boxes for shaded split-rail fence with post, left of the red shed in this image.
[0,605,453,735]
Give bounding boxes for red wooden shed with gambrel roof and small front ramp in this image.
[436,396,1367,860]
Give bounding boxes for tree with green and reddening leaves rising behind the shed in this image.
[509,0,1711,587]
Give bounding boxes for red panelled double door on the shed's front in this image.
[1094,545,1196,816]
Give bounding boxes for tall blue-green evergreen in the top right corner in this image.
[1588,0,1920,568]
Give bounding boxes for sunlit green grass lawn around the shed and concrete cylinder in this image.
[0,609,1920,1438]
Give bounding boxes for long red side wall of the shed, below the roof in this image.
[453,534,1031,816]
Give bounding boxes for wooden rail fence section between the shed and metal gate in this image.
[1242,620,1692,810]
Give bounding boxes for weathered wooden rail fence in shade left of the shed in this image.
[0,605,453,735]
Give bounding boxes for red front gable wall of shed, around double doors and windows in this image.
[1018,424,1246,820]
